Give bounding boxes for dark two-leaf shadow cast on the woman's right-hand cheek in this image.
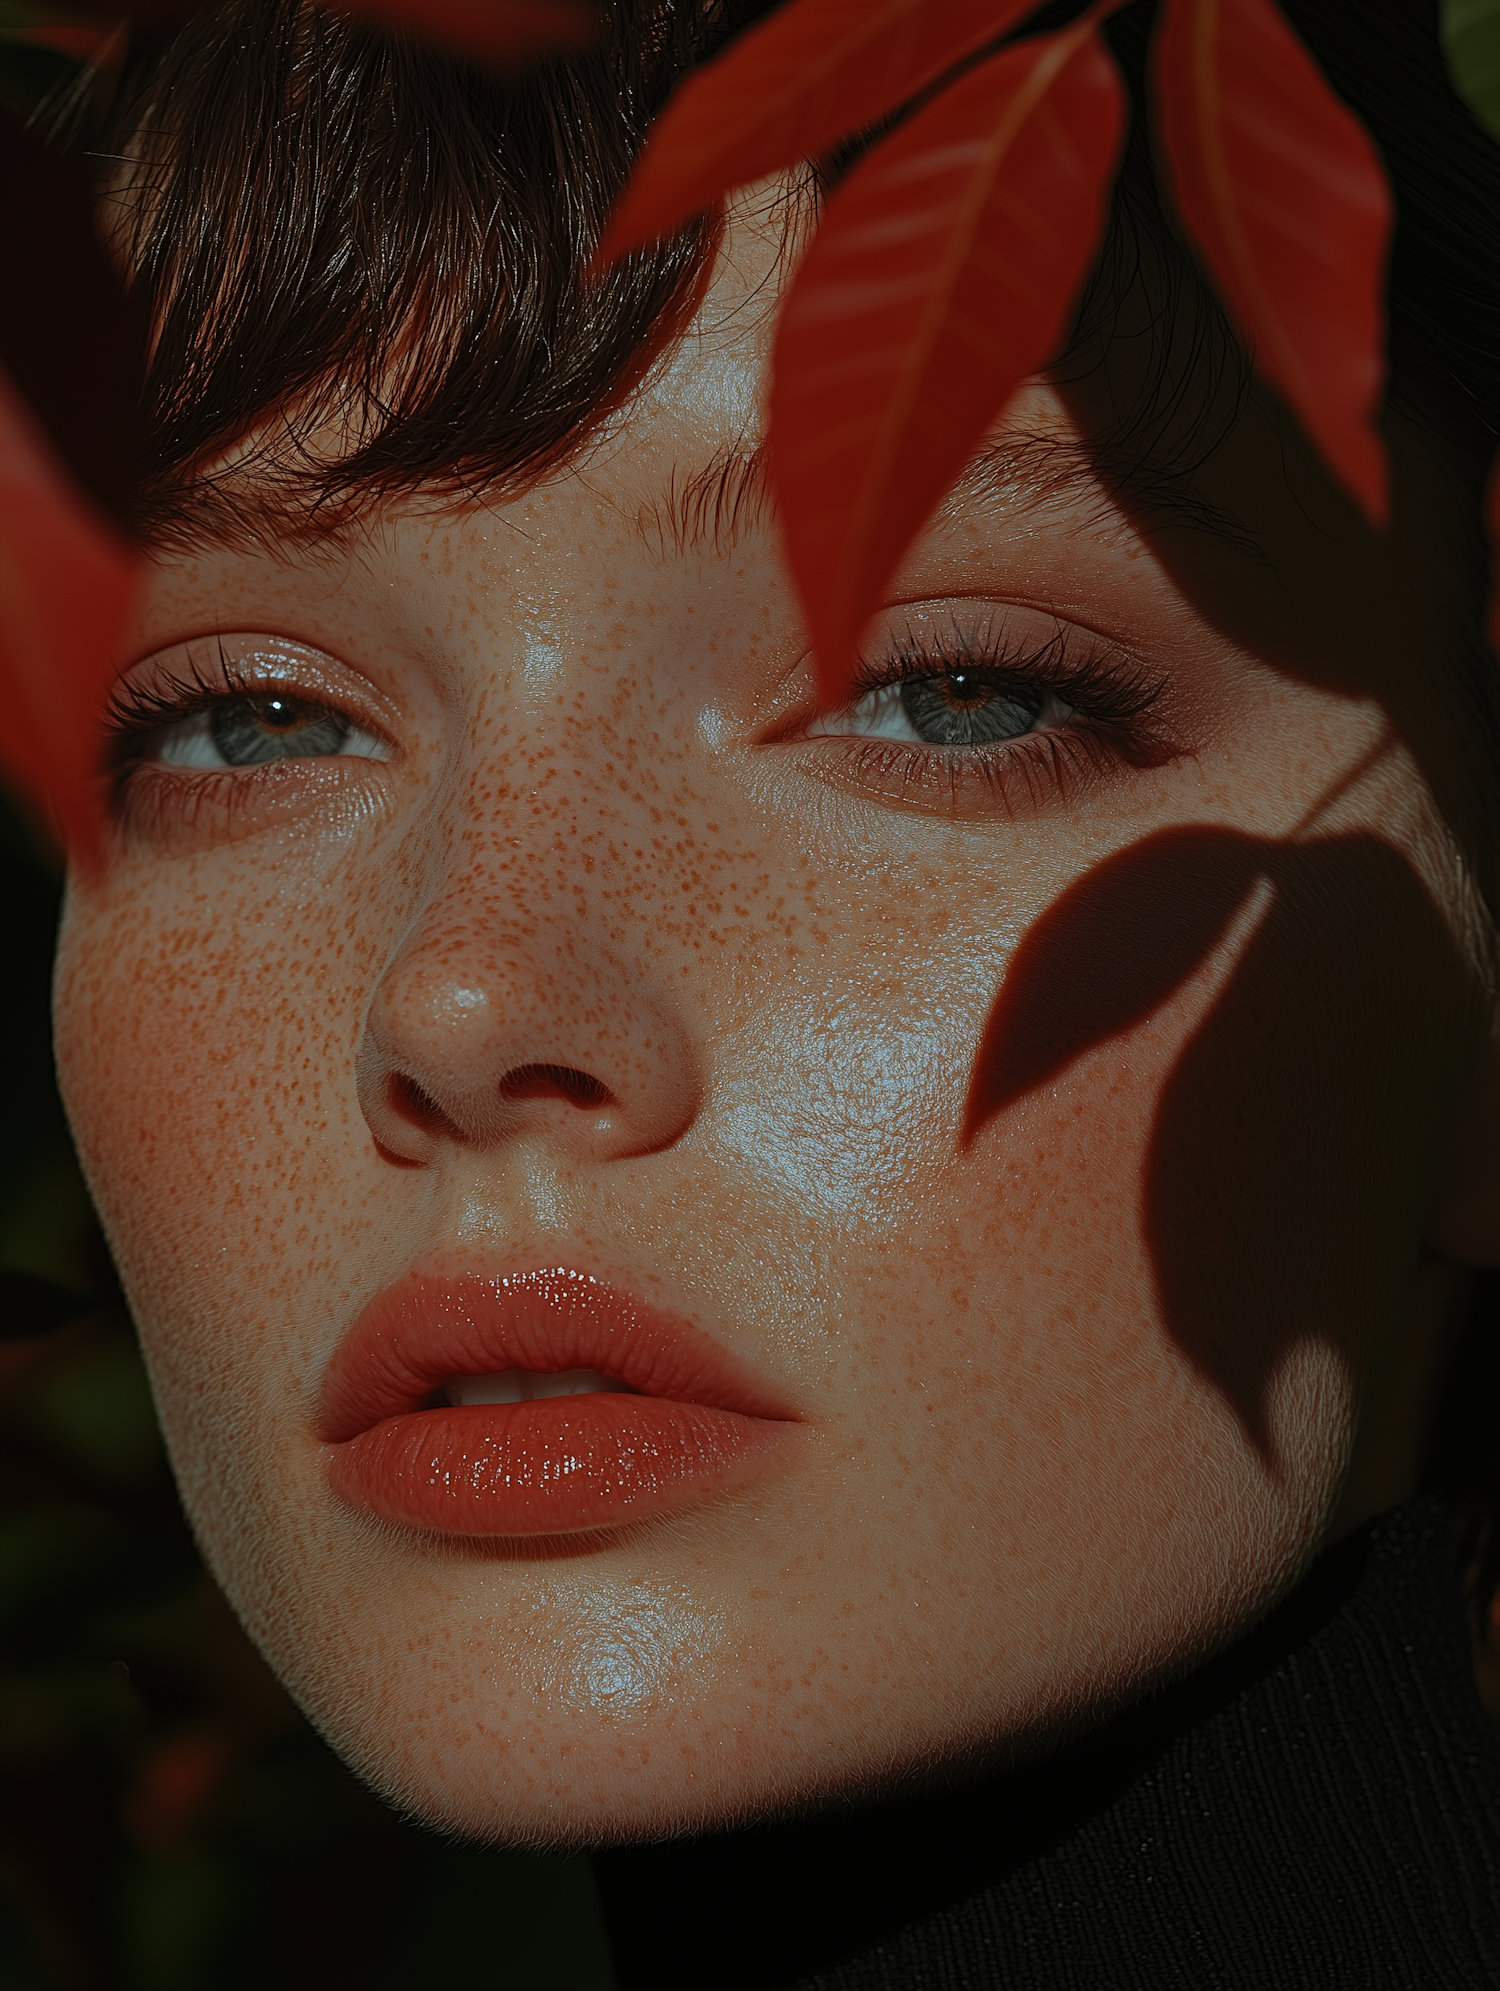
[962,826,1482,1467]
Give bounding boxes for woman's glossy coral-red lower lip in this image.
[327,1392,789,1535]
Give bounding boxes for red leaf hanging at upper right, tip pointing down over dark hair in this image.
[1155,0,1390,526]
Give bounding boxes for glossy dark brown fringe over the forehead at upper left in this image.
[100,0,735,540]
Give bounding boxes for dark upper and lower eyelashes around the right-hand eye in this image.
[820,627,1179,810]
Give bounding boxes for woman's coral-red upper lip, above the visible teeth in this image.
[319,1264,795,1441]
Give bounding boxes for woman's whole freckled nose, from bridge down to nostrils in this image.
[359,780,697,1159]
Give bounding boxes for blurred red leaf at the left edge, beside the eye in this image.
[0,372,137,860]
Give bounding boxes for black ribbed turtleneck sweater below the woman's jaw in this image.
[596,1499,1500,1991]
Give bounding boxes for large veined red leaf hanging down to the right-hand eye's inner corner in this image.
[769,22,1125,701]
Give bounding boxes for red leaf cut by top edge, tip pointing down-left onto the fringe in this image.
[598,0,1038,263]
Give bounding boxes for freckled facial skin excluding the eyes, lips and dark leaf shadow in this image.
[58,210,1484,1844]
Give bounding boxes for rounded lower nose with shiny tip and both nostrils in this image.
[357,892,699,1165]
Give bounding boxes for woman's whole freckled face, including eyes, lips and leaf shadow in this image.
[58,210,1484,1840]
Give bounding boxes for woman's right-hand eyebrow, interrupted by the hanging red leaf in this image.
[637,430,1265,559]
